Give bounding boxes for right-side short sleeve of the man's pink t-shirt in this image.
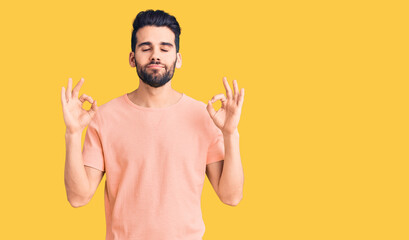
[206,119,224,164]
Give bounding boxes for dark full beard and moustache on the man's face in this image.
[135,59,176,88]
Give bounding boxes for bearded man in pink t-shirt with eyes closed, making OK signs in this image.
[61,10,244,240]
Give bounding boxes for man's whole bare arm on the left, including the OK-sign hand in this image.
[61,78,104,207]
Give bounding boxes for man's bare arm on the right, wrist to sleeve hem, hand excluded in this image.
[206,132,244,206]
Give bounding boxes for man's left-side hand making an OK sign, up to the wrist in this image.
[61,78,98,134]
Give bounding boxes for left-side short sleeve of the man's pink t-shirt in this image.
[82,112,105,172]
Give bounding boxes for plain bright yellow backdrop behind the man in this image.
[0,0,409,240]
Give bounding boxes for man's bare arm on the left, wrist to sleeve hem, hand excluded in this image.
[64,132,104,207]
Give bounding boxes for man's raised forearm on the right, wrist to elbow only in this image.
[219,131,244,205]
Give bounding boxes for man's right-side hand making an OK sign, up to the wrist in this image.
[207,77,244,135]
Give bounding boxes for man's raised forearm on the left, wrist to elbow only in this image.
[64,132,89,207]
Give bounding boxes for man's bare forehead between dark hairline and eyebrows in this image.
[136,26,175,44]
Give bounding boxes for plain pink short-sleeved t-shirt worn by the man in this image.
[82,94,224,240]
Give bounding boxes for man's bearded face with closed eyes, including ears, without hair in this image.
[129,26,182,88]
